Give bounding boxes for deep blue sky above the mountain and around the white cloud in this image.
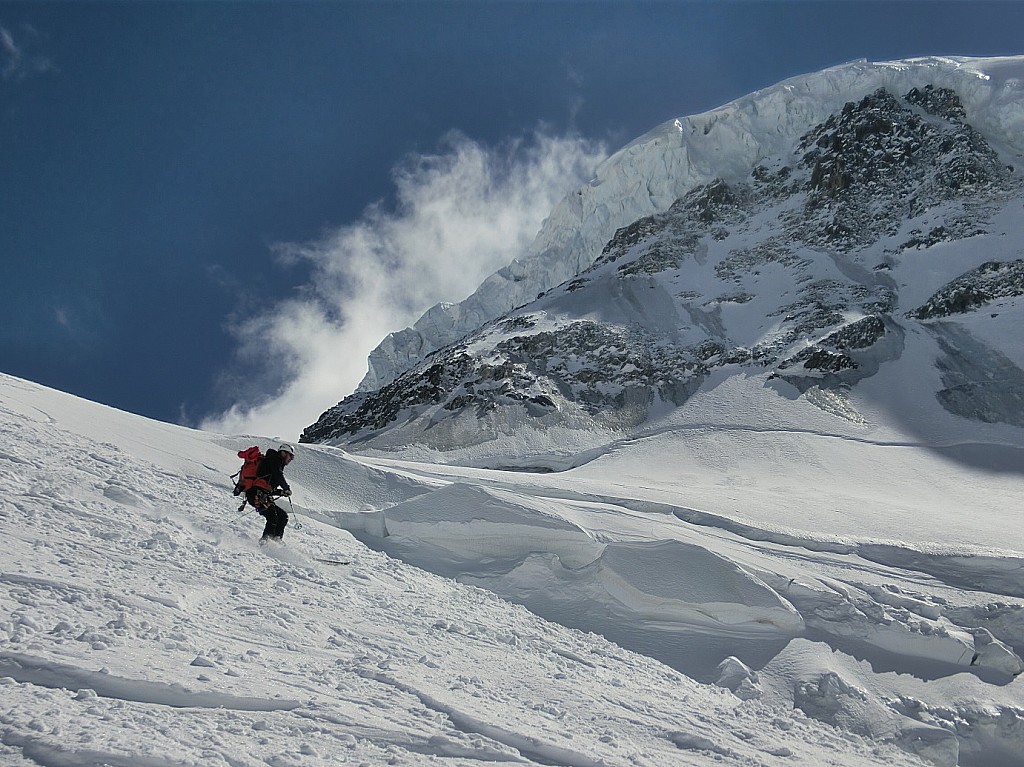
[0,1,1024,436]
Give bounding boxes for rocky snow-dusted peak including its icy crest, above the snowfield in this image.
[303,57,1024,467]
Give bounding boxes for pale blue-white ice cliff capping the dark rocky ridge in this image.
[359,57,1024,391]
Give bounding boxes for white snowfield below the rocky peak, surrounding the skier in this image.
[0,368,1024,767]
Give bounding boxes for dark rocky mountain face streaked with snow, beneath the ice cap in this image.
[302,59,1024,453]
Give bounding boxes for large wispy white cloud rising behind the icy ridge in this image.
[203,133,605,438]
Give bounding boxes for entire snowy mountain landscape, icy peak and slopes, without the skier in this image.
[8,58,1024,767]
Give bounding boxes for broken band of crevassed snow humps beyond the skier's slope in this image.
[325,430,1024,765]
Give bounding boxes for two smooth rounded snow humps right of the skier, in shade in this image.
[339,483,803,632]
